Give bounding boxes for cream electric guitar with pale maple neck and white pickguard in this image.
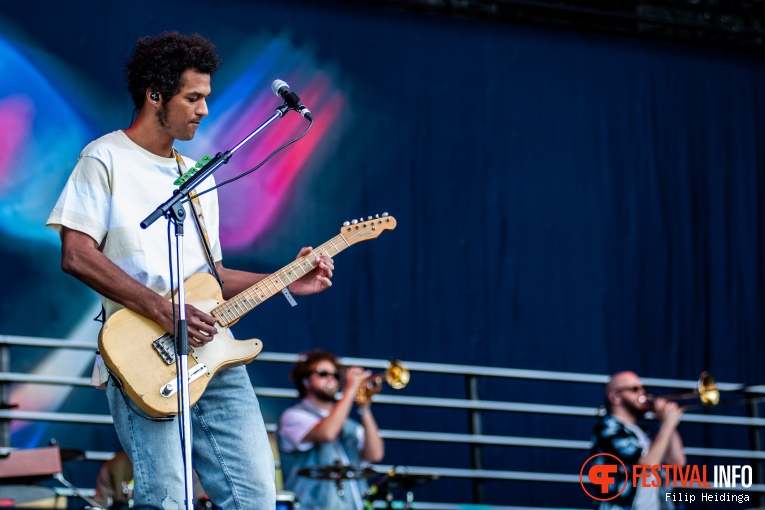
[98,213,396,417]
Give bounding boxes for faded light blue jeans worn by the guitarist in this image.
[106,366,276,510]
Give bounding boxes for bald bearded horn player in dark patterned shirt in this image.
[592,372,685,510]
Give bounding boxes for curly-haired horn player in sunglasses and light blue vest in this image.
[277,350,385,510]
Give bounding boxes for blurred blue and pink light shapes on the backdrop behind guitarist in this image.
[0,30,345,447]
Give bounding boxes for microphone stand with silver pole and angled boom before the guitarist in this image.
[141,103,290,510]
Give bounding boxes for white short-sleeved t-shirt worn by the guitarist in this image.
[46,131,222,317]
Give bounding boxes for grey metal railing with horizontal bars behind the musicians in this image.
[0,335,765,510]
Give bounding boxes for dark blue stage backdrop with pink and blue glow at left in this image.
[0,0,765,507]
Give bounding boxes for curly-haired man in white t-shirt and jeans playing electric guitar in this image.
[47,32,334,510]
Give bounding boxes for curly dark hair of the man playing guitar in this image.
[125,32,220,109]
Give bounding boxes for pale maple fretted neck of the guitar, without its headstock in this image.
[210,235,350,326]
